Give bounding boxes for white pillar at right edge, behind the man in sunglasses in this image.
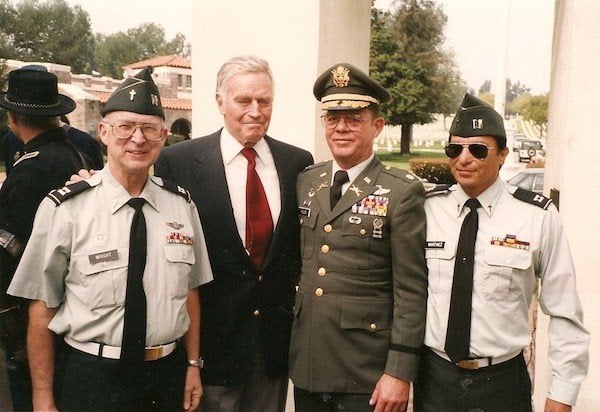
[534,0,600,411]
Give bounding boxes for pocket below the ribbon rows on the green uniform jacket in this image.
[340,214,390,269]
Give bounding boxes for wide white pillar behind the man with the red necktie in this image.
[192,0,371,161]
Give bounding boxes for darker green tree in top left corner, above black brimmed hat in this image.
[0,0,94,73]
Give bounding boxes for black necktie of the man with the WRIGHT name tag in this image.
[121,197,146,366]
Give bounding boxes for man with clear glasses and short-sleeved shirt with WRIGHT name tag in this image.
[8,68,212,411]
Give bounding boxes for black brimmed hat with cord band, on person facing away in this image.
[0,64,76,116]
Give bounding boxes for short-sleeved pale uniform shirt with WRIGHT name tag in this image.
[9,168,212,346]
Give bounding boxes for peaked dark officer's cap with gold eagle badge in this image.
[313,63,390,110]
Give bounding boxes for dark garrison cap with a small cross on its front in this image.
[100,66,165,120]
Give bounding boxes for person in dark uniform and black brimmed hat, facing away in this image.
[0,65,85,411]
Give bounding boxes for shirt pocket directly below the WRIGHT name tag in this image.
[74,247,129,309]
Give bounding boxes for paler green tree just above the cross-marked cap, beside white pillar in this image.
[94,23,190,78]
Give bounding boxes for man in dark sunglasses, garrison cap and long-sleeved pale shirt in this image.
[415,94,589,411]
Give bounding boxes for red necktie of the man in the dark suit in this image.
[242,147,273,269]
